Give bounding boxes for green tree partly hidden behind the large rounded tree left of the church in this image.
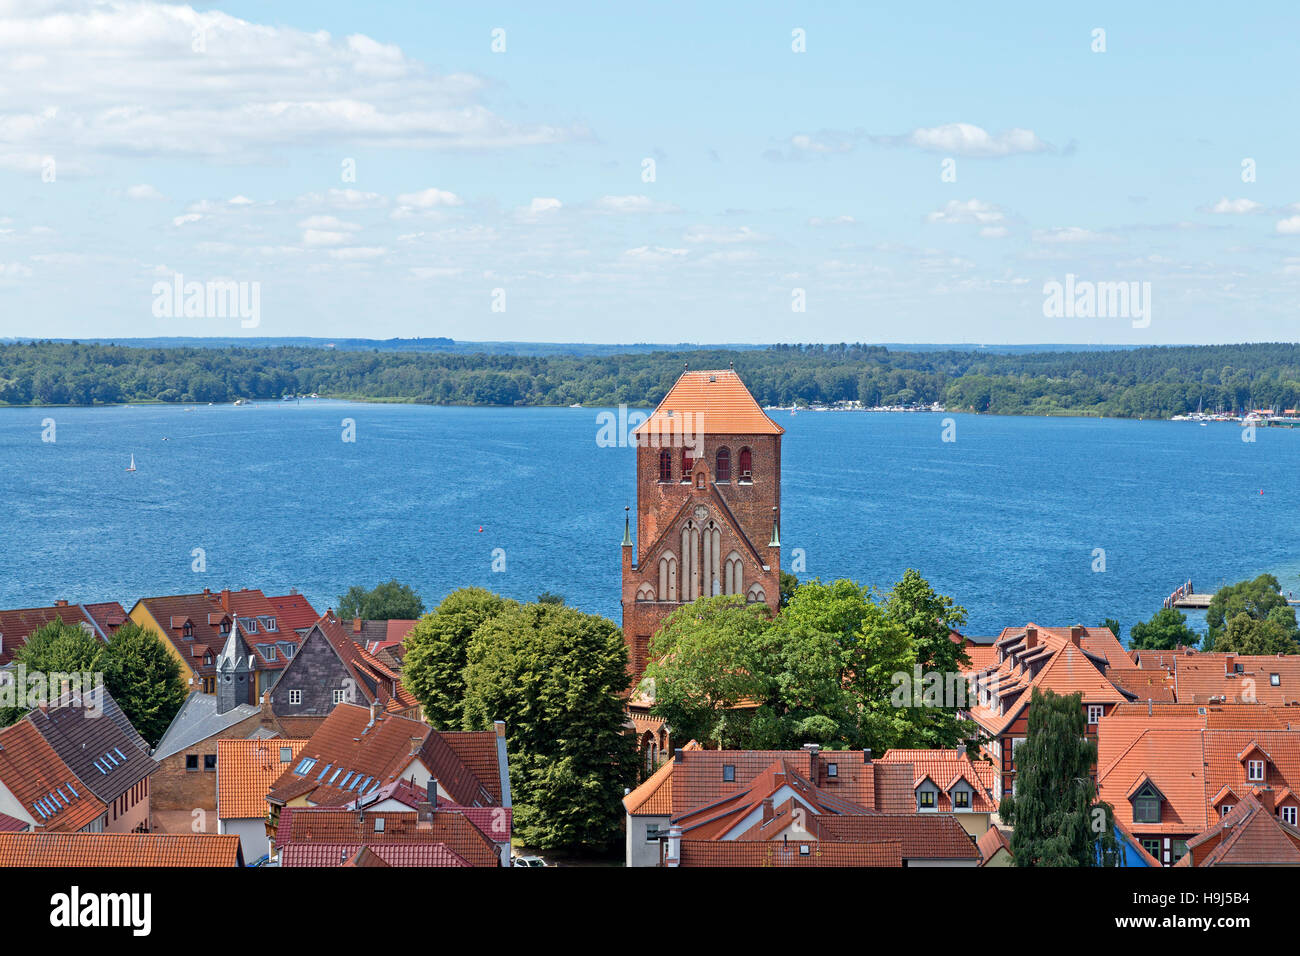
[402,588,516,730]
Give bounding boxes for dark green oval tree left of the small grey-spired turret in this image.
[103,620,186,747]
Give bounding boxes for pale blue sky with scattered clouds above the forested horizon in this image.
[0,0,1300,343]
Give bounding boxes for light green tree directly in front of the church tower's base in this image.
[642,594,771,748]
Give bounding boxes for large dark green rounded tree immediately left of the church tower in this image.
[465,604,637,849]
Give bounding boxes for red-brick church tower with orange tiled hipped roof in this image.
[623,369,784,685]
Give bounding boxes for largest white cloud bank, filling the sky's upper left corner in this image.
[0,0,589,162]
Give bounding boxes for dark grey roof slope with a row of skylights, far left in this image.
[26,687,159,803]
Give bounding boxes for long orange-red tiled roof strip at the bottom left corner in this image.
[0,832,243,868]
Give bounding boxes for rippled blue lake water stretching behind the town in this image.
[0,401,1300,635]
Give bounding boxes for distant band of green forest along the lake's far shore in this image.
[0,342,1300,418]
